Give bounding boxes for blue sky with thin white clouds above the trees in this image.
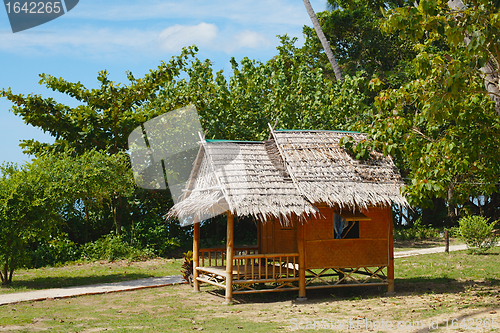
[0,0,326,164]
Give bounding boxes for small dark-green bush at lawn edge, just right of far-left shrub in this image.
[30,233,80,268]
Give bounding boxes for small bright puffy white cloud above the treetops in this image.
[158,22,219,52]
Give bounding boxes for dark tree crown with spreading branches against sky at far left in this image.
[0,48,197,155]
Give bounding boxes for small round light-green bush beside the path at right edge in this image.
[453,215,498,254]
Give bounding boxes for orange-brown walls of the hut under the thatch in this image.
[259,207,392,269]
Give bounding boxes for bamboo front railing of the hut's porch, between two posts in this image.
[233,253,299,283]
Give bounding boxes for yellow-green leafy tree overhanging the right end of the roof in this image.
[346,1,500,223]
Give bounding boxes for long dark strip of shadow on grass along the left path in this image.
[0,273,151,293]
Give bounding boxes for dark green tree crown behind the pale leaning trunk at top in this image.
[303,0,414,89]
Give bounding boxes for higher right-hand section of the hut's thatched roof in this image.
[272,130,408,210]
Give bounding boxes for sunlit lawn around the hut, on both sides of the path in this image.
[0,248,500,332]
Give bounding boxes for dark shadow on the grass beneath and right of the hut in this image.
[210,278,500,304]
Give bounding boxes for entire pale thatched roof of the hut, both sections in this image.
[169,130,407,221]
